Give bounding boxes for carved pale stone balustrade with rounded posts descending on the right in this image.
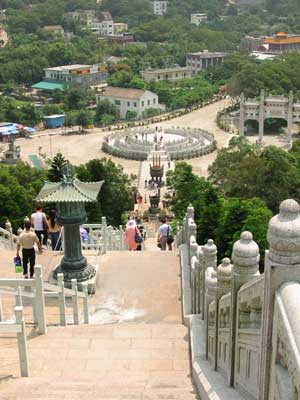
[177,200,300,400]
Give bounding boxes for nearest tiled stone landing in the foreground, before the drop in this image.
[0,323,198,400]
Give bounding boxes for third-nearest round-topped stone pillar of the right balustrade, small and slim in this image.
[214,258,233,371]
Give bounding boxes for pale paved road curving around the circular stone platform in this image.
[17,99,231,176]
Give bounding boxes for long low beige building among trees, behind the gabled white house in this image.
[141,67,192,82]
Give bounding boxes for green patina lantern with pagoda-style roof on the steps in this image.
[36,176,104,282]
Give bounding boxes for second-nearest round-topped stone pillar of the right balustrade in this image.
[228,231,259,386]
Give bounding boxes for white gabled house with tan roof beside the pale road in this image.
[97,87,165,119]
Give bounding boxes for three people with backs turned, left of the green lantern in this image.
[17,206,61,278]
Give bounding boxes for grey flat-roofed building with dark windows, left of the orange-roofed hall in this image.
[186,50,227,74]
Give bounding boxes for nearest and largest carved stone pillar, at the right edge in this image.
[259,199,300,400]
